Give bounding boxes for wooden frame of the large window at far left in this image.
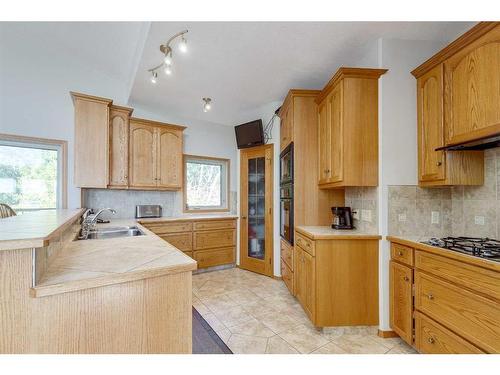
[0,133,68,212]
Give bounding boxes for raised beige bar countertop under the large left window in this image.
[0,209,83,251]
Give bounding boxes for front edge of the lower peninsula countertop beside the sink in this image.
[30,261,198,298]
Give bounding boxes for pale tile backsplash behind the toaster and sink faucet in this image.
[82,189,237,219]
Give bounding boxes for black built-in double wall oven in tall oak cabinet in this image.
[280,143,294,245]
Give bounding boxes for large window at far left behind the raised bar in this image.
[0,134,66,213]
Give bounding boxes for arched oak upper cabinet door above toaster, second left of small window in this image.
[129,123,157,188]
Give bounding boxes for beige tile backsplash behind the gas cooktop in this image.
[389,148,500,238]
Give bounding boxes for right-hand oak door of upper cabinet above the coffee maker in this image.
[328,81,344,182]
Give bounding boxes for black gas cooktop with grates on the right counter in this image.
[423,237,500,262]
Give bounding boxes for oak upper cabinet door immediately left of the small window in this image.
[156,128,182,189]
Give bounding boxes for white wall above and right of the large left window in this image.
[0,23,137,208]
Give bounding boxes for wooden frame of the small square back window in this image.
[182,154,231,213]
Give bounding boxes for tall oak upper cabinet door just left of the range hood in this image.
[417,65,445,181]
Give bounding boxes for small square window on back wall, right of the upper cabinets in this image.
[184,155,229,212]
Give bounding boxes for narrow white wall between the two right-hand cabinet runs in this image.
[372,39,452,330]
